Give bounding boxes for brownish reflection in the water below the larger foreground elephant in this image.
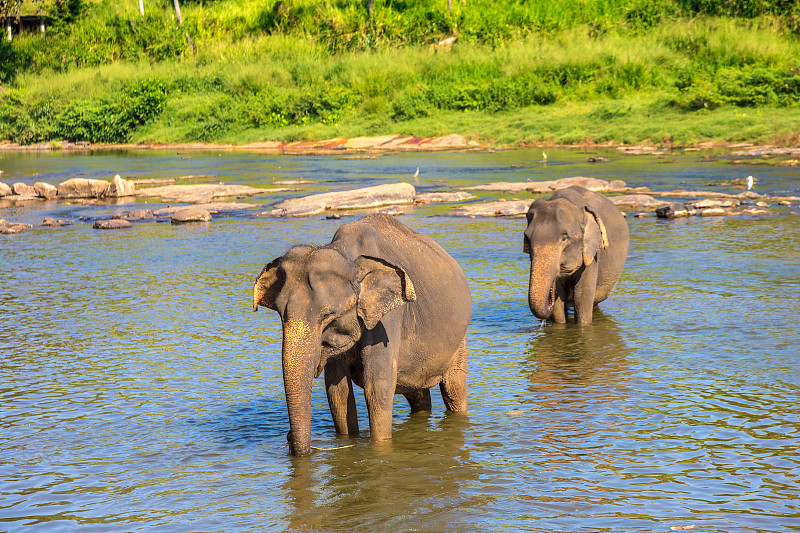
[284,415,480,532]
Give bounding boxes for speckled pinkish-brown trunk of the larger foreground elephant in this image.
[283,321,321,455]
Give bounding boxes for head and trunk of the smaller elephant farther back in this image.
[523,190,608,319]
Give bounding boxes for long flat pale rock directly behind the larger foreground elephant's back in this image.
[270,183,416,217]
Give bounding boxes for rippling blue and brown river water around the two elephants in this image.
[0,149,800,533]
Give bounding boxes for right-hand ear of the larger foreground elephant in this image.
[356,255,417,329]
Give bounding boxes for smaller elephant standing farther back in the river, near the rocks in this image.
[524,187,628,324]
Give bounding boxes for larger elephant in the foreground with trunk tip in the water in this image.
[253,214,472,455]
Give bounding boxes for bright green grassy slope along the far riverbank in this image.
[0,0,800,145]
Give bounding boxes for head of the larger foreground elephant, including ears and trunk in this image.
[253,246,416,455]
